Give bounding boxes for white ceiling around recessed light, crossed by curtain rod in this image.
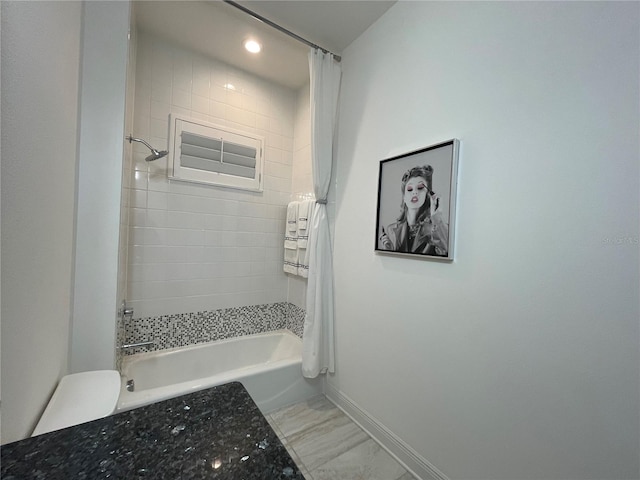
[132,0,396,88]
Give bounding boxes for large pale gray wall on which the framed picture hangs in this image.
[329,2,640,480]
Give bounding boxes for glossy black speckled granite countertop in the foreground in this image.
[0,382,304,480]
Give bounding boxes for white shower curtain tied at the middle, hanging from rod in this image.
[302,49,341,378]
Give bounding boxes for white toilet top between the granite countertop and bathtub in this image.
[31,370,120,437]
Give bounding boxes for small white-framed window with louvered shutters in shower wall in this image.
[169,115,264,192]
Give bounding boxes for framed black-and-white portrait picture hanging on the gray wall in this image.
[375,139,459,261]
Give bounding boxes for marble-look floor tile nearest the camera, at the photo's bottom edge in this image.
[311,440,413,480]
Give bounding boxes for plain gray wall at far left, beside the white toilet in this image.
[2,1,82,443]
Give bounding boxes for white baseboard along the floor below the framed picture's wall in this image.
[325,382,449,480]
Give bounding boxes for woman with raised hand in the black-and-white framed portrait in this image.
[380,165,449,257]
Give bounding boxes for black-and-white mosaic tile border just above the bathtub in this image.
[118,302,305,355]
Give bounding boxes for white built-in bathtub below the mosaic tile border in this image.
[117,330,322,413]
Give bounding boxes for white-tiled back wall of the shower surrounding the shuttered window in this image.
[127,32,308,318]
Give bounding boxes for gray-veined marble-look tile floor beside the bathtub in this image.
[266,395,415,480]
